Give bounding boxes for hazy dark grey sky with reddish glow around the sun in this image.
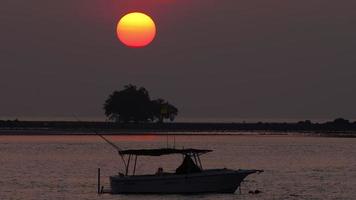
[0,0,356,119]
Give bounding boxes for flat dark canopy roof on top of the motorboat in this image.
[119,148,212,156]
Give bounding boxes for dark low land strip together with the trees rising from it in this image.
[0,84,356,137]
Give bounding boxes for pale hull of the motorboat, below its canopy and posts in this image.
[110,169,258,194]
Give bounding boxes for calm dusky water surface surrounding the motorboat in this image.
[0,136,356,200]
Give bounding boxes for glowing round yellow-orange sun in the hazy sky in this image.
[116,12,156,47]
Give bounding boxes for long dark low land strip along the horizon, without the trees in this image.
[0,118,356,137]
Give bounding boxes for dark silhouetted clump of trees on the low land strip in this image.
[104,85,178,123]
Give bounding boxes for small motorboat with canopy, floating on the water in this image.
[110,148,263,194]
